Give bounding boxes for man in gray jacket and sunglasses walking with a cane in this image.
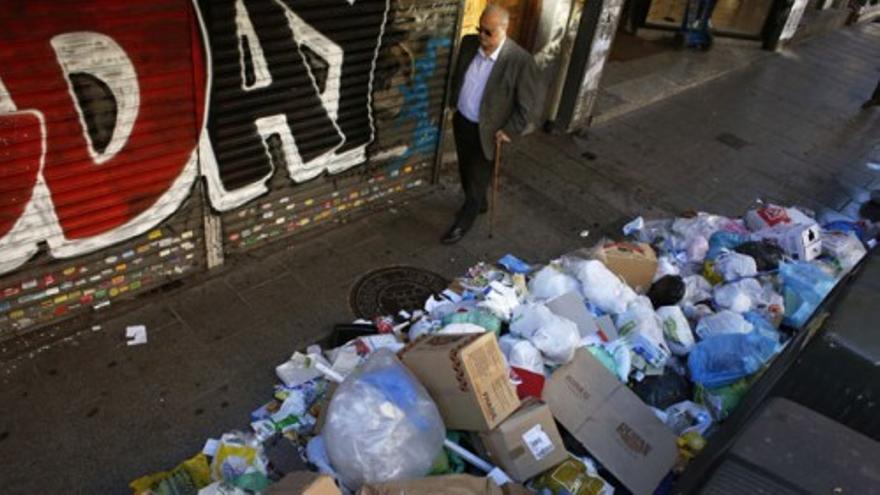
[442,5,537,244]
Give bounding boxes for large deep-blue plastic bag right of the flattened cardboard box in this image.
[688,331,779,388]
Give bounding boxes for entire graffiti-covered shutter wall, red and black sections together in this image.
[0,0,459,340]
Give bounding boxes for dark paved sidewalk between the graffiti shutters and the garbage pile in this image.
[0,21,880,494]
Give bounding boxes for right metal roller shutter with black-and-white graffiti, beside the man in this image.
[199,0,459,254]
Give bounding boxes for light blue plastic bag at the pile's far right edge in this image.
[779,261,836,328]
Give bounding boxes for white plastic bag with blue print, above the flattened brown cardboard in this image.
[614,296,670,368]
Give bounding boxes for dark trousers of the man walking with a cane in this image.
[452,112,494,230]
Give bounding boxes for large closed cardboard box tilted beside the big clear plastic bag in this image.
[399,332,519,431]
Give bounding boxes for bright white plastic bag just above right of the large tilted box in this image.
[510,304,581,364]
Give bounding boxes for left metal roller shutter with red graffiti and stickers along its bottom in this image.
[0,0,205,340]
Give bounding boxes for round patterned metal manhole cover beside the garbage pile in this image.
[349,266,449,319]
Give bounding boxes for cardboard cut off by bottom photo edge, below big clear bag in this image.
[357,474,532,495]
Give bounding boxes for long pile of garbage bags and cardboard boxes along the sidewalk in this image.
[131,205,873,495]
